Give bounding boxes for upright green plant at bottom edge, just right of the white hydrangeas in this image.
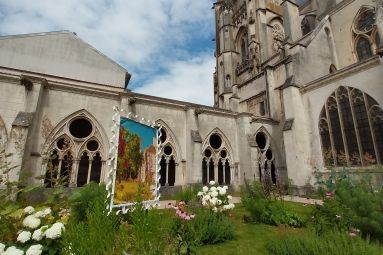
[63,199,127,255]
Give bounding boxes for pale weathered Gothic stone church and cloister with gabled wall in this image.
[0,0,383,191]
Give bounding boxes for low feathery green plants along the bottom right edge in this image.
[266,232,383,255]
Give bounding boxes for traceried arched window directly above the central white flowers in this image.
[202,132,231,185]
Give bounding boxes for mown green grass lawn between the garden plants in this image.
[197,202,313,255]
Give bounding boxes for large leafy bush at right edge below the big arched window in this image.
[312,171,383,242]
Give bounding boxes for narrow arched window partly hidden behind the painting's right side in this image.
[160,127,176,186]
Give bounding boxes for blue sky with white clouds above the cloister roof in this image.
[0,0,215,105]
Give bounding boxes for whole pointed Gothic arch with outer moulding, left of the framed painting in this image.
[42,109,108,187]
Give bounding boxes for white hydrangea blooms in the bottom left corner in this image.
[0,206,65,255]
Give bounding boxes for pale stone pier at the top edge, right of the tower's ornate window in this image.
[281,0,302,41]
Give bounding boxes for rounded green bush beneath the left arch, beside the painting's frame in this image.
[69,182,107,222]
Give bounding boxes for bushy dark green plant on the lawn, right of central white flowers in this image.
[241,182,304,227]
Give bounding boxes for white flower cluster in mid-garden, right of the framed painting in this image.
[197,181,234,212]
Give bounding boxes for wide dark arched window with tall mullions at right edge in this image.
[319,87,383,166]
